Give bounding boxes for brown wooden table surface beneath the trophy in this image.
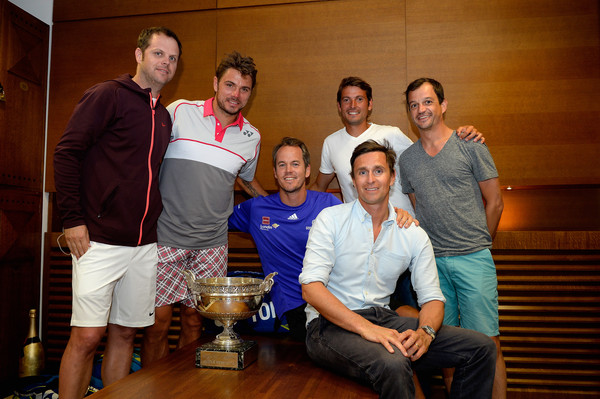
[92,336,378,399]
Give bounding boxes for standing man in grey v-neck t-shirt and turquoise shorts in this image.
[399,78,506,398]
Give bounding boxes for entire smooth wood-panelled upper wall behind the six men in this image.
[46,0,600,191]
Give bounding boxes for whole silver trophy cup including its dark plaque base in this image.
[183,271,277,370]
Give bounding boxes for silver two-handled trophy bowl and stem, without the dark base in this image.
[183,271,277,350]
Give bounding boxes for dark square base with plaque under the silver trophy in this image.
[196,341,258,370]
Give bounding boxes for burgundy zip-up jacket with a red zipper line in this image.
[54,74,171,246]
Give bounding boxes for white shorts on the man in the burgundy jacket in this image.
[71,241,158,327]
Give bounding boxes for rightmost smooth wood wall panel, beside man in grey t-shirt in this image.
[406,0,600,186]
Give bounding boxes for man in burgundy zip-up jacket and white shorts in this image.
[54,27,181,399]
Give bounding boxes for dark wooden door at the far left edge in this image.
[0,0,49,386]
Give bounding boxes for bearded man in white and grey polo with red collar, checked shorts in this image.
[142,52,267,365]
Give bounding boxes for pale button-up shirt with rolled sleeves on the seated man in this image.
[299,200,445,322]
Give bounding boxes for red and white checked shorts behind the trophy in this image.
[156,245,228,308]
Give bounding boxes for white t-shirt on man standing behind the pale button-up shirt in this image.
[319,123,414,216]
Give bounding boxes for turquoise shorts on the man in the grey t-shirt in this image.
[435,249,500,337]
